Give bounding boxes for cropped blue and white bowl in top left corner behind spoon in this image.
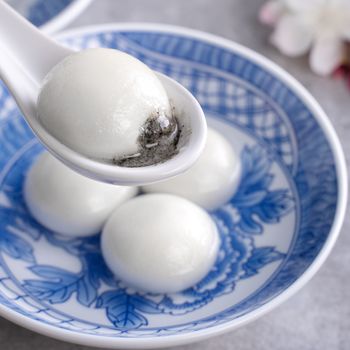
[5,0,91,33]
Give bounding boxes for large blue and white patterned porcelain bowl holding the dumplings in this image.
[0,24,347,348]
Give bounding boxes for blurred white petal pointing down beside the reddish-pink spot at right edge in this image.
[310,38,345,75]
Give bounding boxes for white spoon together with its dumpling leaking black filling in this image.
[0,2,206,185]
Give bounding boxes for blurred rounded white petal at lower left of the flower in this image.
[271,15,312,56]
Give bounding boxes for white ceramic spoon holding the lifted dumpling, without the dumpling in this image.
[0,0,207,185]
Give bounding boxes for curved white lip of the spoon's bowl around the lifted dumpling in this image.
[30,73,207,186]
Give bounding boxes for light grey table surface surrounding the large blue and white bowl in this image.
[0,0,350,350]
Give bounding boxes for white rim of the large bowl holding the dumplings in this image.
[0,22,348,349]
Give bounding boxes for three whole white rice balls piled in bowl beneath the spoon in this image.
[24,128,240,293]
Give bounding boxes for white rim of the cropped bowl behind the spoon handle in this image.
[39,0,92,34]
